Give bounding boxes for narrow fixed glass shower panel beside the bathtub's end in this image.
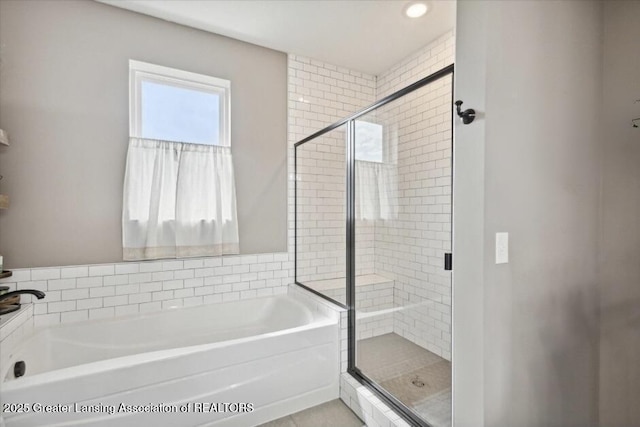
[295,124,347,306]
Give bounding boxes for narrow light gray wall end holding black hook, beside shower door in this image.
[452,1,489,427]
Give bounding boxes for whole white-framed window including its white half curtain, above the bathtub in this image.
[122,61,240,260]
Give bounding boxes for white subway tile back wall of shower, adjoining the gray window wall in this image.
[288,55,376,304]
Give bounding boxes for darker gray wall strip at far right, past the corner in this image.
[600,1,640,427]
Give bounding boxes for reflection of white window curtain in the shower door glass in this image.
[355,160,398,220]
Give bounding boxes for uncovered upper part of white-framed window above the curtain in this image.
[129,60,231,146]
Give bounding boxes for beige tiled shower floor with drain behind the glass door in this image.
[357,333,451,427]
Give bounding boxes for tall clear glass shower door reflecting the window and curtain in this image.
[352,74,452,427]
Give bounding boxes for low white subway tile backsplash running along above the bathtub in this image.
[0,253,293,327]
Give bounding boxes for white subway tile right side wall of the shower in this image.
[374,32,455,360]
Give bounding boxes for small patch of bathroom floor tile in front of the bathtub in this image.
[260,399,364,427]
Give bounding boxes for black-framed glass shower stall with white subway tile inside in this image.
[295,65,453,427]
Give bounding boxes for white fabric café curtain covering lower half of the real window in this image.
[122,138,239,260]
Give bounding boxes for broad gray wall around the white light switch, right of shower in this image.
[454,1,602,427]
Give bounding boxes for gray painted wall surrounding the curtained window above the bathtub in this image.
[0,0,287,268]
